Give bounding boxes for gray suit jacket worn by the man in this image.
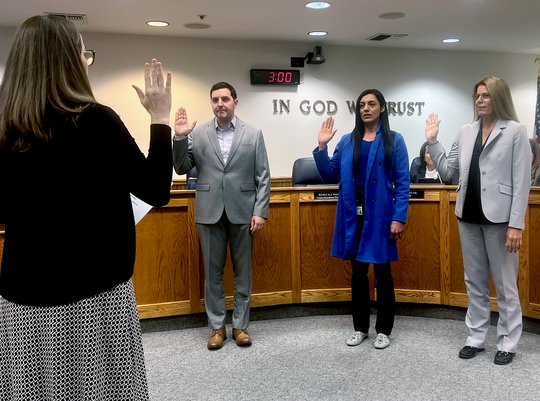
[173,117,270,224]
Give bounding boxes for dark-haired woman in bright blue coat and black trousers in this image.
[313,89,410,349]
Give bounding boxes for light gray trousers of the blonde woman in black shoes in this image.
[458,221,523,352]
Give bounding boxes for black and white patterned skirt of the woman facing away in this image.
[0,280,148,401]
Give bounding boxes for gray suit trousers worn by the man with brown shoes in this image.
[196,213,252,329]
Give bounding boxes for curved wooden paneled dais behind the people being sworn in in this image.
[0,185,540,318]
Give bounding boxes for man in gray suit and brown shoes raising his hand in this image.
[173,82,270,350]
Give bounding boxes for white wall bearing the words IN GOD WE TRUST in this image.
[0,30,537,177]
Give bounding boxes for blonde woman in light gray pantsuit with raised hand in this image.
[425,76,532,365]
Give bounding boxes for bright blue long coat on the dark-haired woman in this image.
[313,131,410,263]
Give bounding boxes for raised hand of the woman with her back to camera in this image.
[132,58,171,125]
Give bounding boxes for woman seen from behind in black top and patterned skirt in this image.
[0,16,172,401]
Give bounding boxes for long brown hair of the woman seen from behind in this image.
[0,15,96,152]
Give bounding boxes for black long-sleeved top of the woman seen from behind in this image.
[0,105,172,306]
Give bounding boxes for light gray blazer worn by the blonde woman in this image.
[429,120,532,229]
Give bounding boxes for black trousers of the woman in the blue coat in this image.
[351,209,396,336]
